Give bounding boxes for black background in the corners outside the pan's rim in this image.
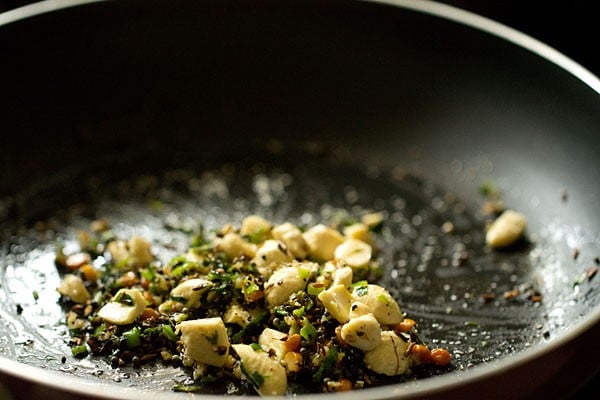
[0,0,600,400]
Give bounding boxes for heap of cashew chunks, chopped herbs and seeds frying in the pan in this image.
[56,214,450,396]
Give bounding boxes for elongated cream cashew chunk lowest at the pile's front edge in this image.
[231,344,287,396]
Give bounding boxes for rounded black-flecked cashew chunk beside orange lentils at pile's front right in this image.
[364,331,412,376]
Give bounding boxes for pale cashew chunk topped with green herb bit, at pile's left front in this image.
[98,289,147,325]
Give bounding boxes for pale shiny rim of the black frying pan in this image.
[0,0,600,399]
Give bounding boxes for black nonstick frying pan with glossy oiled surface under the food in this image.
[0,1,600,398]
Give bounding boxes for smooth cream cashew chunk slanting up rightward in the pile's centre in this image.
[265,264,311,307]
